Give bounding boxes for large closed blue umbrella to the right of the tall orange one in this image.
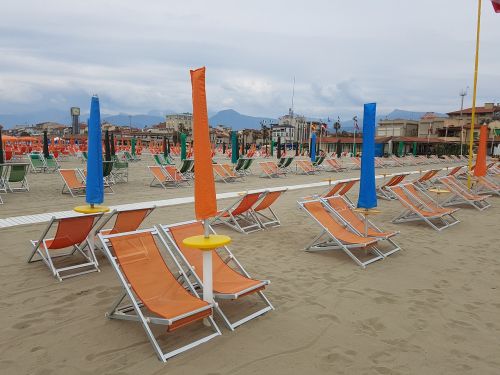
[358,103,377,209]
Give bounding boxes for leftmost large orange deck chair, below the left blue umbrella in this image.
[28,213,102,281]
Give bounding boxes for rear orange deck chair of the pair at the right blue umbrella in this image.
[321,196,401,257]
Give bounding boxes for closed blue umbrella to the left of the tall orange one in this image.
[85,96,104,205]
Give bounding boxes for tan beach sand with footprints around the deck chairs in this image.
[0,157,500,375]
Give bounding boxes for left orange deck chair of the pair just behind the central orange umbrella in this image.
[210,192,266,234]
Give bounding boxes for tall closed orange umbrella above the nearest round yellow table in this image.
[191,67,217,220]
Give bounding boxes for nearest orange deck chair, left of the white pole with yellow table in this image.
[99,228,221,362]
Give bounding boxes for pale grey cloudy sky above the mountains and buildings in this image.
[0,0,500,117]
